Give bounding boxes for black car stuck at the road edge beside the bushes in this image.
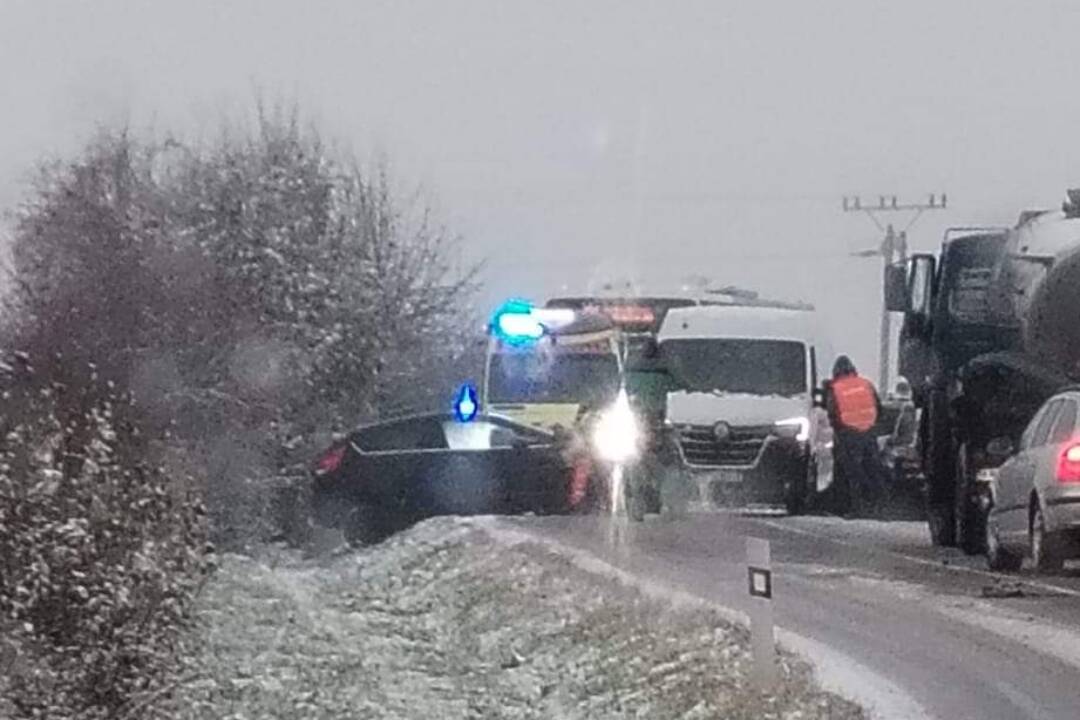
[312,413,572,544]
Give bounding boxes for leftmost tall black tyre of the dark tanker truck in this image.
[923,390,957,547]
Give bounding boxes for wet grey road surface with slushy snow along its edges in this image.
[500,513,1080,720]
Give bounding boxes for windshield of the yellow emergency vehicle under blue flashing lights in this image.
[488,352,619,405]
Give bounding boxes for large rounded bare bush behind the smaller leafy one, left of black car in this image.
[1,112,473,546]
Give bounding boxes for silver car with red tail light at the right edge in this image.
[981,388,1080,572]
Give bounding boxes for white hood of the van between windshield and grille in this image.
[667,391,810,425]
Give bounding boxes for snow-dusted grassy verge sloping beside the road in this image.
[166,518,864,720]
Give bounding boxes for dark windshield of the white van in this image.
[661,338,807,397]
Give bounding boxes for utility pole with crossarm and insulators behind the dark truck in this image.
[843,192,948,394]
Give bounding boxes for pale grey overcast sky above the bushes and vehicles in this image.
[0,0,1080,379]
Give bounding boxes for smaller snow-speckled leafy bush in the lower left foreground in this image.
[0,365,208,719]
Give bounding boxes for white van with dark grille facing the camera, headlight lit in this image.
[658,305,834,513]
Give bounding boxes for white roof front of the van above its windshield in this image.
[658,305,820,344]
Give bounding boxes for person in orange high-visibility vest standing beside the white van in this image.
[825,355,888,515]
